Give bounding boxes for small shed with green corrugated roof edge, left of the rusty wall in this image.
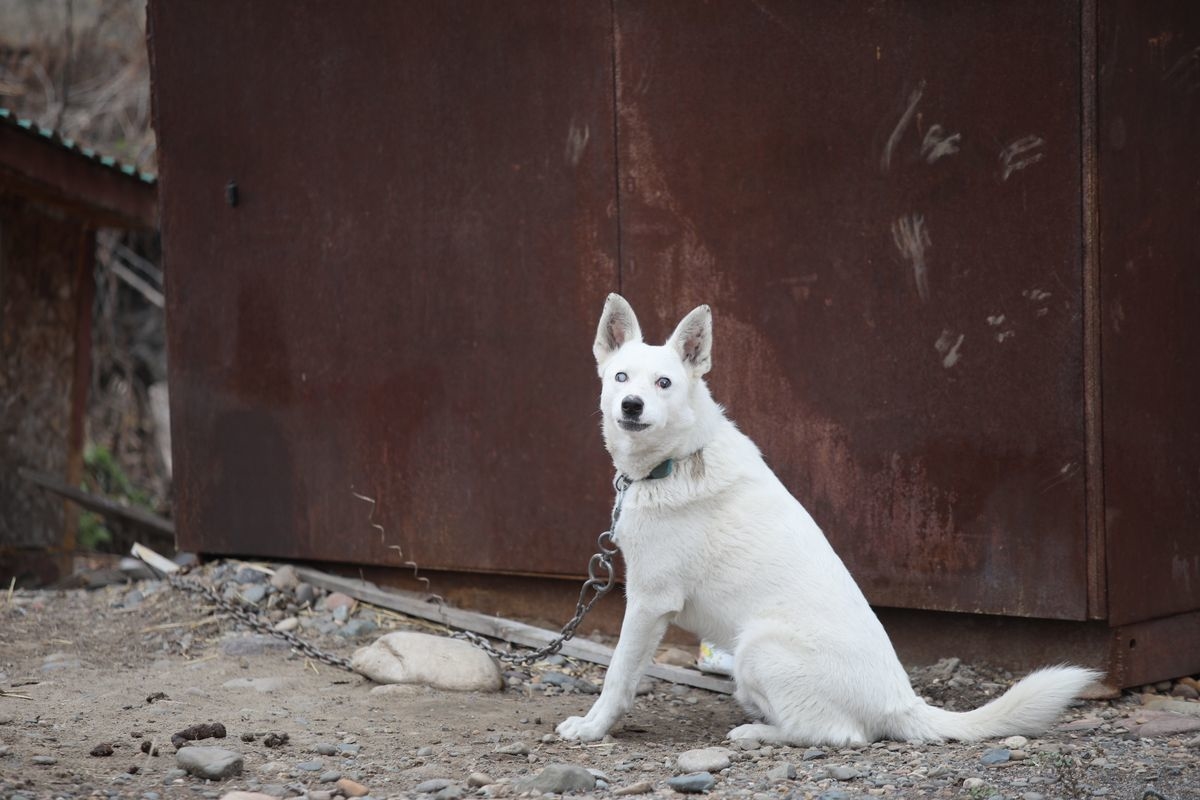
[0,109,157,588]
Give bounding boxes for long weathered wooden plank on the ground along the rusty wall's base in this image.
[296,567,733,694]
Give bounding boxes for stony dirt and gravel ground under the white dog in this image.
[0,564,1200,800]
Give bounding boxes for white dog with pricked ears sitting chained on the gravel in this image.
[558,295,1099,746]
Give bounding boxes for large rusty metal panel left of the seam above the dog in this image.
[149,0,617,573]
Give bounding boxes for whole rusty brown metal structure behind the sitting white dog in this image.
[149,0,1200,685]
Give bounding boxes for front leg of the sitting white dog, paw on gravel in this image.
[557,602,672,741]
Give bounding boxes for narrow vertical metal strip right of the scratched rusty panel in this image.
[1080,0,1108,619]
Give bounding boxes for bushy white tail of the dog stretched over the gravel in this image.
[893,666,1103,741]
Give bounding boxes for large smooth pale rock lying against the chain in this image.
[350,631,504,692]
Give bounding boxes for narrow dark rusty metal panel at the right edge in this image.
[1097,0,1200,623]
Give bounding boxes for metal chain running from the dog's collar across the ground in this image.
[159,475,634,672]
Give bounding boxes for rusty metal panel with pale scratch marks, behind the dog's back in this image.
[616,0,1087,619]
